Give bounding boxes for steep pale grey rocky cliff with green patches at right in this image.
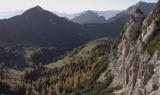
[99,1,160,95]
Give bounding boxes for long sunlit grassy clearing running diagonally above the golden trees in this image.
[45,39,108,69]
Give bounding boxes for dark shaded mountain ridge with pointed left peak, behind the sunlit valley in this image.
[0,2,154,56]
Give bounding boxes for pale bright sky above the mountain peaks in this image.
[0,0,158,13]
